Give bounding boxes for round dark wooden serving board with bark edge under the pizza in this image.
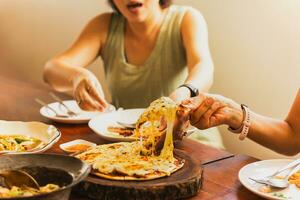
[74,150,203,200]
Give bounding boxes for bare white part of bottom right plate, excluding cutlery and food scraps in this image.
[239,159,300,200]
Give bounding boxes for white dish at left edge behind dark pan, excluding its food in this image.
[0,120,61,154]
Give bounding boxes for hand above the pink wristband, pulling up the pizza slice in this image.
[181,94,243,129]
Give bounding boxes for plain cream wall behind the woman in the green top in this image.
[0,0,300,158]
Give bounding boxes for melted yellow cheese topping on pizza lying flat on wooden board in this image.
[76,142,179,177]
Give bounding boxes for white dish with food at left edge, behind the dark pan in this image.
[0,120,61,154]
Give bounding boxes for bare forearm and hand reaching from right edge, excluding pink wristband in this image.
[182,90,300,155]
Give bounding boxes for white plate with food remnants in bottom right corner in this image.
[239,159,300,200]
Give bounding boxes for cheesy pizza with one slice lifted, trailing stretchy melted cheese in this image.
[77,97,184,180]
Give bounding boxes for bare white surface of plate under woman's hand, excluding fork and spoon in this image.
[40,100,115,124]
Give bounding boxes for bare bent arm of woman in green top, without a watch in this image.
[44,14,111,110]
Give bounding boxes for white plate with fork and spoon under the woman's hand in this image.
[40,100,115,124]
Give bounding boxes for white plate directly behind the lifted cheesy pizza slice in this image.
[89,108,145,142]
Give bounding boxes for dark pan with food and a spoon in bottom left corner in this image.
[0,154,90,200]
